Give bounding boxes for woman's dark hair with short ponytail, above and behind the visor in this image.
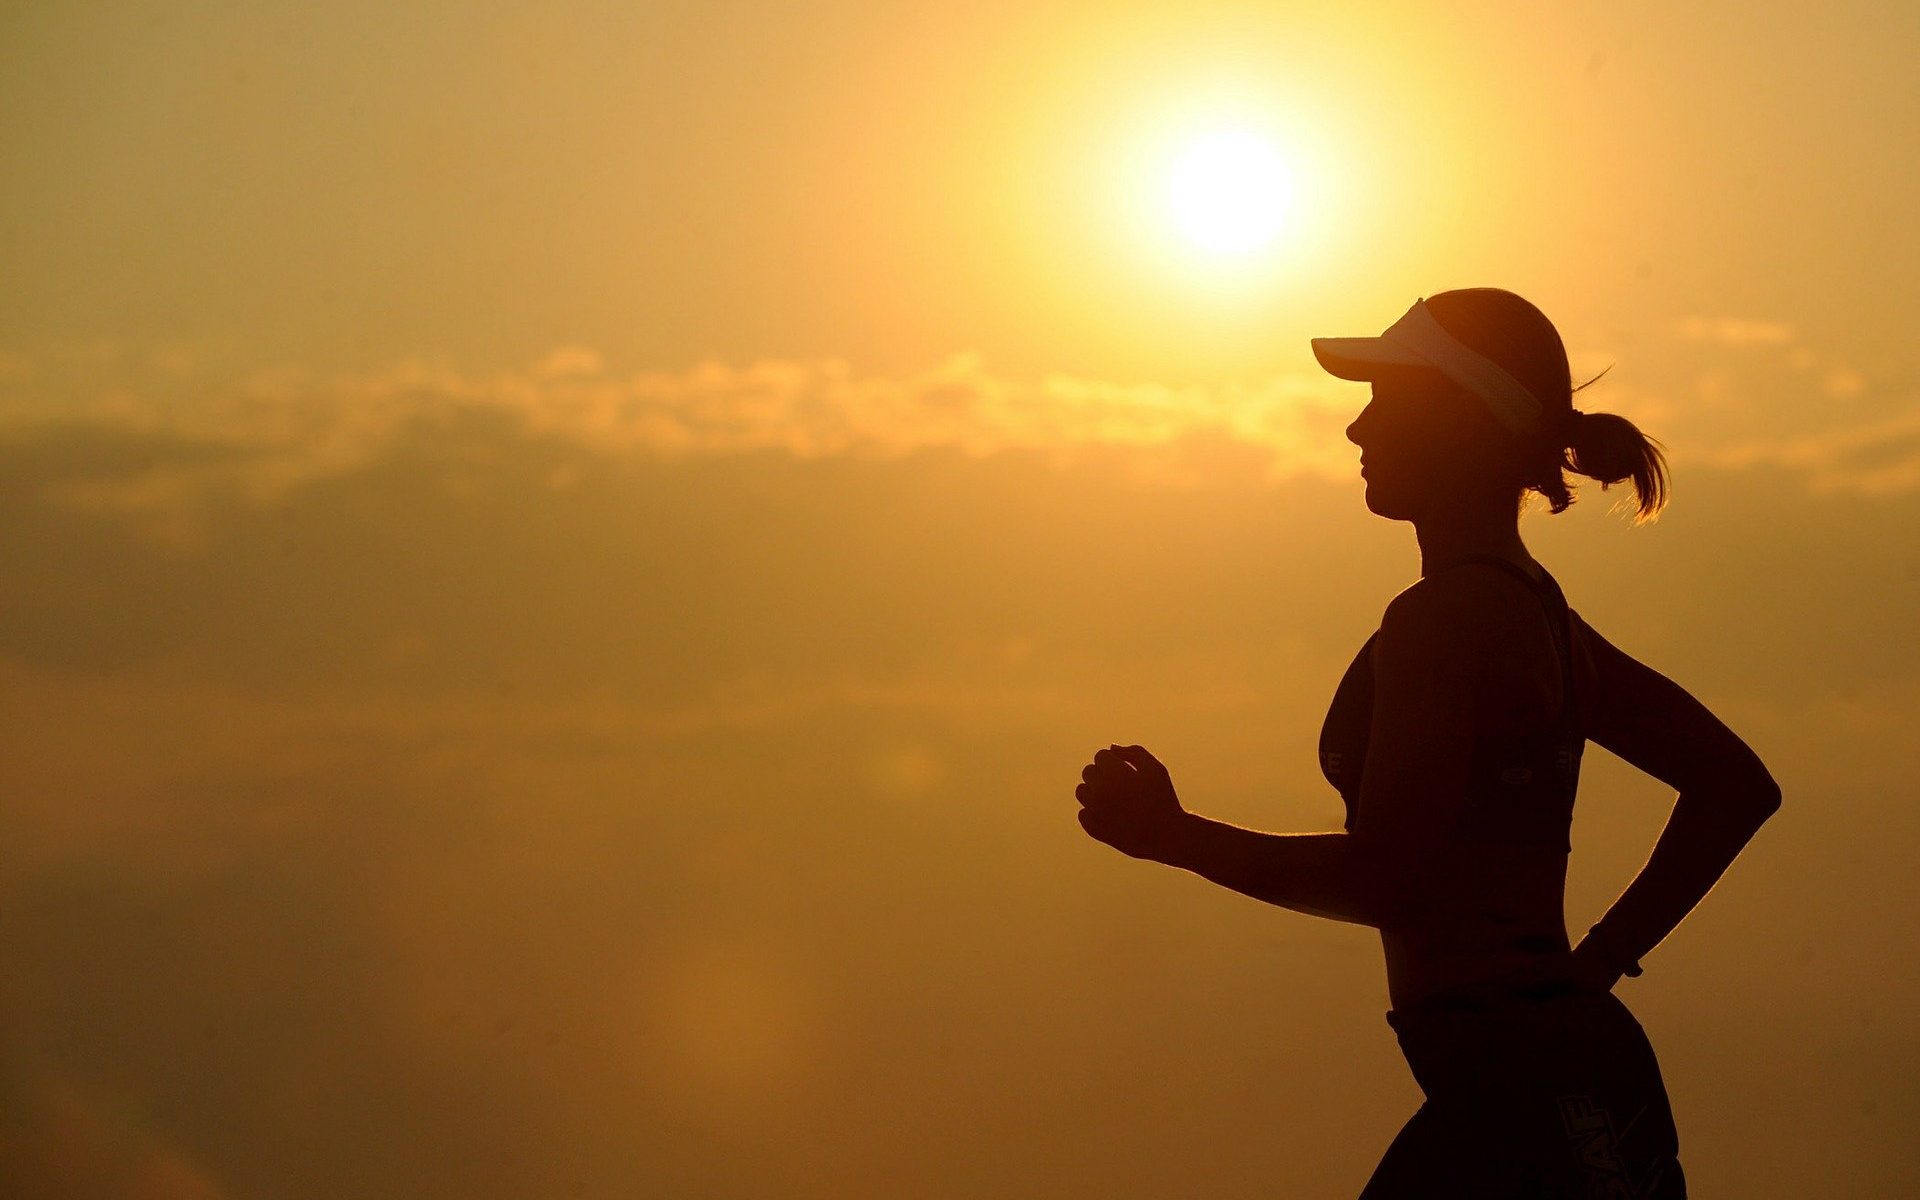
[1427,288,1670,524]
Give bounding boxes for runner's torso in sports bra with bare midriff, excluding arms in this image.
[1321,563,1586,1010]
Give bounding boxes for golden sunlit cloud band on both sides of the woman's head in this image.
[0,332,1920,555]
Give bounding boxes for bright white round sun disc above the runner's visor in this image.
[1167,129,1292,253]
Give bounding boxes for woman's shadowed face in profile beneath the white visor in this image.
[1346,369,1500,520]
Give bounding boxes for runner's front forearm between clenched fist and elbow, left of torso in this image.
[1160,814,1380,925]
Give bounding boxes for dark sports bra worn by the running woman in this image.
[1319,555,1586,852]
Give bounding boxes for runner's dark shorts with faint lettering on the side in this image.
[1359,985,1686,1200]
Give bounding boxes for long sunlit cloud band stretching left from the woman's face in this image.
[0,346,1365,553]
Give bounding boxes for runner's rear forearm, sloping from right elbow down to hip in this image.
[1596,789,1780,964]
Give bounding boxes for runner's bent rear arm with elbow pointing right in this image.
[1578,622,1780,979]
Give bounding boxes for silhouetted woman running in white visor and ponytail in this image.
[1075,288,1780,1200]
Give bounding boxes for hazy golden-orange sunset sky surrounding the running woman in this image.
[0,0,1920,1200]
